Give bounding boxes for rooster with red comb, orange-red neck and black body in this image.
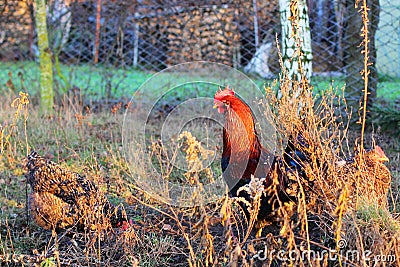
[214,88,307,221]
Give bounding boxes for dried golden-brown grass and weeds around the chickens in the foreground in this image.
[0,1,400,266]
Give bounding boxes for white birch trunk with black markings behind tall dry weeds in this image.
[279,0,312,82]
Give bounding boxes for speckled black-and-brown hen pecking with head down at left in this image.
[26,151,131,232]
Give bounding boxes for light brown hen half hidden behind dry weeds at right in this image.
[336,146,392,206]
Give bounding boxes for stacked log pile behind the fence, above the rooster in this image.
[140,6,240,66]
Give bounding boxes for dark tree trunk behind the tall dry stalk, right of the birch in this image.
[343,0,380,111]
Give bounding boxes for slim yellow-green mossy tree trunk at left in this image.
[36,0,54,115]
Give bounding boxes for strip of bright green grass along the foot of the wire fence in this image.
[0,61,400,101]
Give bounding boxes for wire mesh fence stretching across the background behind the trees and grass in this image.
[0,0,400,99]
